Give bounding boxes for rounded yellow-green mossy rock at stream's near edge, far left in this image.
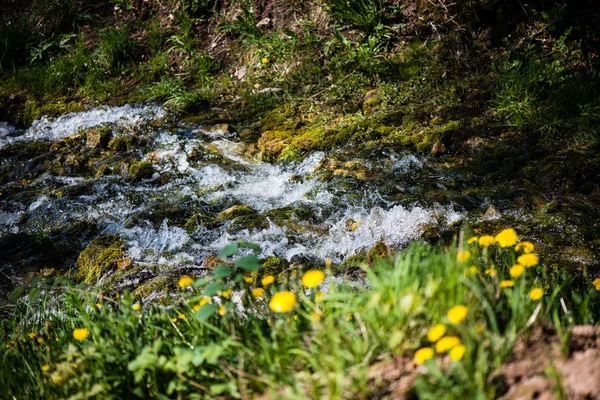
[76,235,125,285]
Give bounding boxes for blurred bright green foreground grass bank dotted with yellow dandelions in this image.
[0,230,600,399]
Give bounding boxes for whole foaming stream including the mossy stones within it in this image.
[0,105,464,298]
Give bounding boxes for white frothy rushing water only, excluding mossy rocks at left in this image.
[0,106,461,290]
